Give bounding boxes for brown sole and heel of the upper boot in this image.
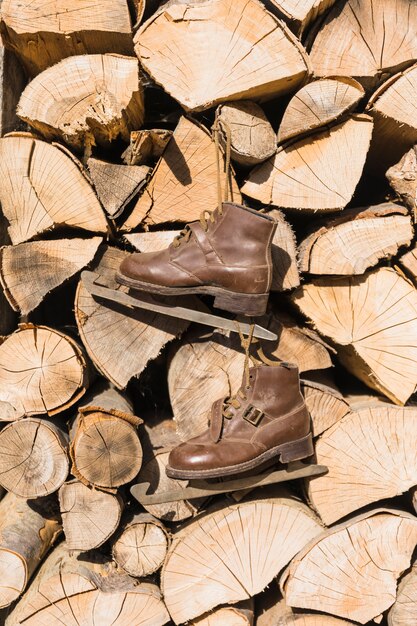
[116,273,269,317]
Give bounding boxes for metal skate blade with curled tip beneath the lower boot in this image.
[130,461,328,506]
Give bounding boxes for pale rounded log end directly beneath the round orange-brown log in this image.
[59,480,123,552]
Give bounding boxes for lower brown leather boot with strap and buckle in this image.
[166,363,314,479]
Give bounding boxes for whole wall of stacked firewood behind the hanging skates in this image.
[0,0,417,626]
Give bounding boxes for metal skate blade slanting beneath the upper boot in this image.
[81,270,278,341]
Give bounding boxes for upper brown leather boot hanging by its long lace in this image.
[116,203,277,316]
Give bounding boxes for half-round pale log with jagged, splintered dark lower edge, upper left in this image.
[17,54,144,151]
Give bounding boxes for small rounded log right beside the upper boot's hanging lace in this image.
[214,100,277,167]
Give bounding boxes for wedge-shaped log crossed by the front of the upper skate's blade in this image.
[75,248,190,389]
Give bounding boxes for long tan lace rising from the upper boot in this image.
[172,109,232,248]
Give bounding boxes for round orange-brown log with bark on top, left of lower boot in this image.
[70,383,142,489]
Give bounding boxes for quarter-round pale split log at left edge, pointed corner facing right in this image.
[0,136,107,244]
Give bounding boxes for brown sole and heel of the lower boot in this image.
[165,433,314,480]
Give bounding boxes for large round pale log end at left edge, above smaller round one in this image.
[0,324,91,421]
